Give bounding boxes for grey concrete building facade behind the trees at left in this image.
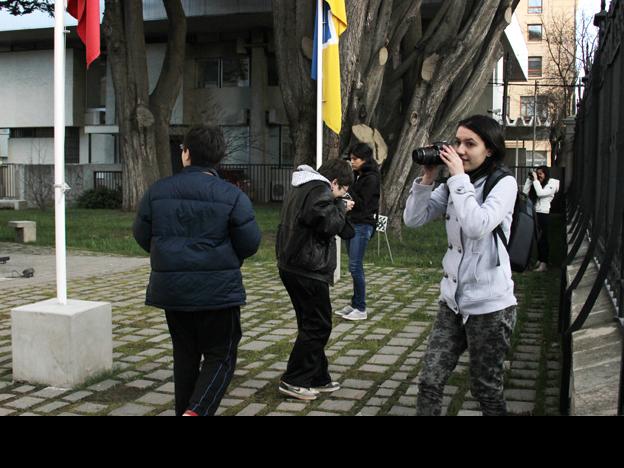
[0,0,293,205]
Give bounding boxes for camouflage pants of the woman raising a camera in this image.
[417,304,516,416]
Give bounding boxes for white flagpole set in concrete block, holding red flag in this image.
[54,0,67,305]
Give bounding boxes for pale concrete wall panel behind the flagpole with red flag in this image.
[0,50,75,128]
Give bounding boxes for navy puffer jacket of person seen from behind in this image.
[134,167,261,312]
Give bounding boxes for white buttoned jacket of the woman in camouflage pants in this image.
[403,174,518,321]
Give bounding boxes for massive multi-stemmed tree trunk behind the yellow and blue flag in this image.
[273,0,519,232]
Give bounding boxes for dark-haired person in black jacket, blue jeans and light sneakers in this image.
[336,144,381,322]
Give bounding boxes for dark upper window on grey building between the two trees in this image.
[197,57,251,89]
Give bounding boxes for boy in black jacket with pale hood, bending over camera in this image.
[276,160,354,401]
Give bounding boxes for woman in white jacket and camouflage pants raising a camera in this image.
[404,116,518,416]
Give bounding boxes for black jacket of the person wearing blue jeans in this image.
[349,164,381,226]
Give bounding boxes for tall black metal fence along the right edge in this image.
[560,0,624,415]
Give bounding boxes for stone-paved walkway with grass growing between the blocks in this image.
[0,249,559,416]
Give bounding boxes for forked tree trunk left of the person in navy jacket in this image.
[103,0,186,211]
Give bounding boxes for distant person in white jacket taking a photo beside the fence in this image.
[523,166,560,273]
